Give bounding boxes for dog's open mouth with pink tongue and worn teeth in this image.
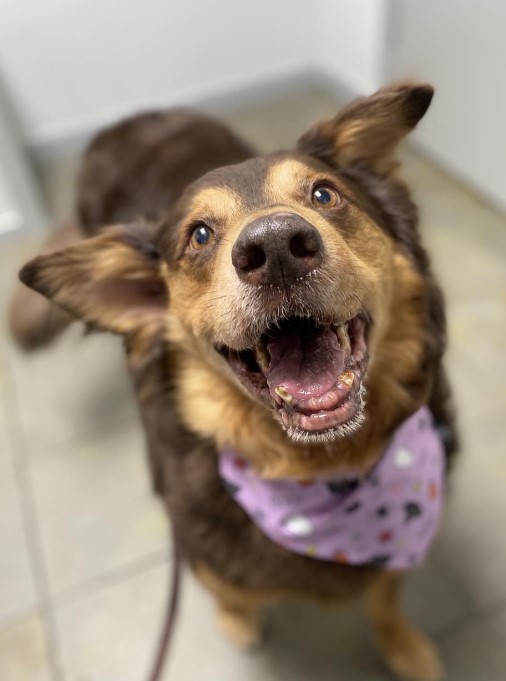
[219,314,368,441]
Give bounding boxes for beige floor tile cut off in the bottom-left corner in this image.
[0,616,51,681]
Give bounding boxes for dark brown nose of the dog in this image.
[232,213,323,286]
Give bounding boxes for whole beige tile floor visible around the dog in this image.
[0,92,506,681]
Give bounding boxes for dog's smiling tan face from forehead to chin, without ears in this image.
[160,154,393,441]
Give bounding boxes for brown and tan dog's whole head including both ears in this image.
[21,85,443,454]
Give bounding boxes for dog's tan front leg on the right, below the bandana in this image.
[367,572,445,681]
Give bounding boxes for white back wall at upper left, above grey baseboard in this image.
[0,0,313,148]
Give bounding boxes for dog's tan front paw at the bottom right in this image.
[380,629,445,681]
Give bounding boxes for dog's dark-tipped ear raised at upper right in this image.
[297,83,434,173]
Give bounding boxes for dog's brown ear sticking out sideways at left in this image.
[19,224,168,334]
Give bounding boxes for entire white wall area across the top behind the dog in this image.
[0,0,506,212]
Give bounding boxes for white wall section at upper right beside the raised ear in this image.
[388,0,506,209]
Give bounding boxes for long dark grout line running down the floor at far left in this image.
[6,367,65,681]
